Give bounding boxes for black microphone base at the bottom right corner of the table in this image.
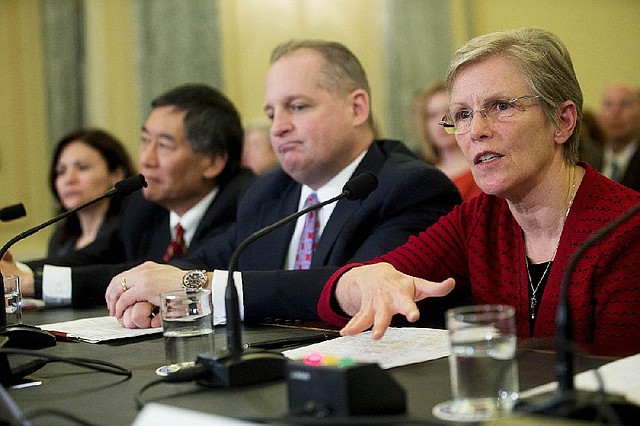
[514,390,640,425]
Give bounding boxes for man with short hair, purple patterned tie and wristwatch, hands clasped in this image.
[106,41,460,327]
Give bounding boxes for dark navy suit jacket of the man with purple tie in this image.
[172,140,460,322]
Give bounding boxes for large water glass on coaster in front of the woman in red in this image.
[433,305,518,422]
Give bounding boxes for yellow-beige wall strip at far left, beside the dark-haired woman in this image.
[0,0,52,258]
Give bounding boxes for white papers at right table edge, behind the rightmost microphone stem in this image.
[520,354,640,405]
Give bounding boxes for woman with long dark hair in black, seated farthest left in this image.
[47,129,134,258]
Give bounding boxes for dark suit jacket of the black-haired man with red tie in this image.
[36,170,255,307]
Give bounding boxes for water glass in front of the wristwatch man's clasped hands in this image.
[157,289,214,375]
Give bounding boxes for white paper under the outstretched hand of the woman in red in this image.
[283,327,451,369]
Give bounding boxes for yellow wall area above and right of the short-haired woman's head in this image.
[476,0,640,109]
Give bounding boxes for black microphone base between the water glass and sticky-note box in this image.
[196,349,287,388]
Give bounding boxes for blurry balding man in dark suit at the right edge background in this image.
[594,83,640,191]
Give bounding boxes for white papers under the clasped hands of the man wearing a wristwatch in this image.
[40,316,162,343]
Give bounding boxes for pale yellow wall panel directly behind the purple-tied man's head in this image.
[219,0,385,133]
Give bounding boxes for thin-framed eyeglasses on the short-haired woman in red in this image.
[438,95,540,135]
